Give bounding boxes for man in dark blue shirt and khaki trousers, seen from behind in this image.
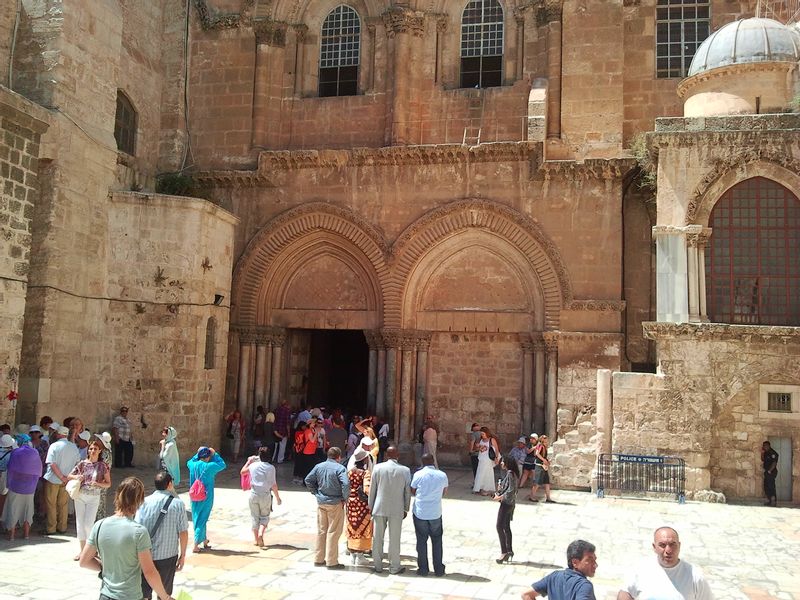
[306,446,350,569]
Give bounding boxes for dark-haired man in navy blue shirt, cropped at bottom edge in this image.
[522,540,597,600]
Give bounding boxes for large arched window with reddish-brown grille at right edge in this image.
[706,177,800,326]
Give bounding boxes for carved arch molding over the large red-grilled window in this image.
[685,147,800,227]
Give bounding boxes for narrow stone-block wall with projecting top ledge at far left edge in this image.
[0,86,49,423]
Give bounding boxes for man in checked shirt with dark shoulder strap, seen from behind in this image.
[135,471,189,600]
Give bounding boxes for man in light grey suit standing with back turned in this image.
[369,446,411,575]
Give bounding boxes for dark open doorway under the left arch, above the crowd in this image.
[308,329,369,415]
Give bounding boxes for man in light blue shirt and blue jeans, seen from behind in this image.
[411,453,448,577]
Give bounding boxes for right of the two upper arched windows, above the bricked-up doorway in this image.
[461,0,503,88]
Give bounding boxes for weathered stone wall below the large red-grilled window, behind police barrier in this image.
[612,323,800,500]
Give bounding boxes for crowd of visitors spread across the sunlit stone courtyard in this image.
[0,402,724,600]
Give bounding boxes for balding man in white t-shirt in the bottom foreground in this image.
[617,527,714,600]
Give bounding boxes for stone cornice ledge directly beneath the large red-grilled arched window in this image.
[642,321,800,344]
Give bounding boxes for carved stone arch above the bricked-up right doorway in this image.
[384,200,572,330]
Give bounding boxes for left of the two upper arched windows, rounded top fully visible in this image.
[319,4,361,96]
